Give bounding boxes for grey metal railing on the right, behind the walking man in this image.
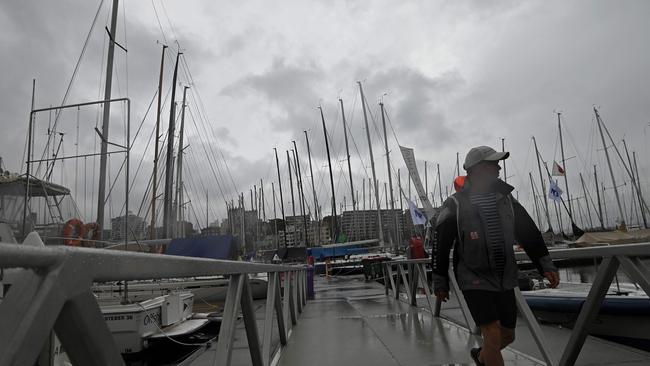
[382,243,650,366]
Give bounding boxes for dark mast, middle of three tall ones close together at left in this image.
[163,52,183,238]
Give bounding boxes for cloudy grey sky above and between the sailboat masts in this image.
[0,0,650,232]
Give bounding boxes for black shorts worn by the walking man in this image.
[463,290,517,329]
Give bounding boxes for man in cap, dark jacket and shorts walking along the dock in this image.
[431,146,560,366]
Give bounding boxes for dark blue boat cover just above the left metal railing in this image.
[165,235,237,260]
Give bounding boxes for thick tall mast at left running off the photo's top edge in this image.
[97,0,120,240]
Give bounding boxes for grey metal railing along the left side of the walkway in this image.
[0,243,307,366]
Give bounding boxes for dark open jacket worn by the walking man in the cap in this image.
[431,180,557,291]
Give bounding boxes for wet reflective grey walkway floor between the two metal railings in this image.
[278,277,537,366]
